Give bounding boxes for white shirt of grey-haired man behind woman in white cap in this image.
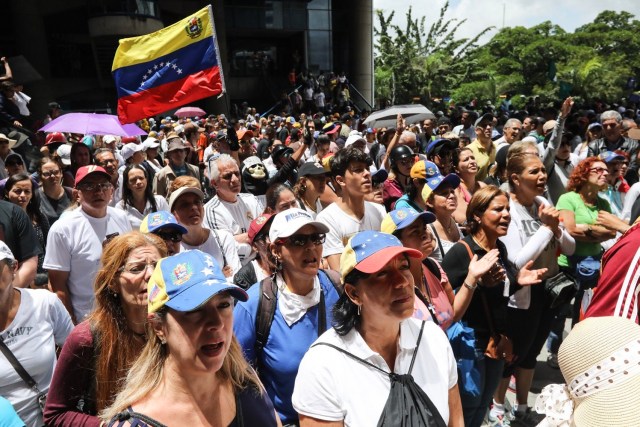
[202,193,264,265]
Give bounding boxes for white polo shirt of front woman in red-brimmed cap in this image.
[292,318,458,427]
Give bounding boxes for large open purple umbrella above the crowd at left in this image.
[39,113,146,136]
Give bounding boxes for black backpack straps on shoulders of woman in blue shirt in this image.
[254,269,342,366]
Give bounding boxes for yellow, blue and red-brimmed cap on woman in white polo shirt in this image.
[340,230,422,283]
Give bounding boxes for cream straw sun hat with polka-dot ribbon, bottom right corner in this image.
[536,317,640,427]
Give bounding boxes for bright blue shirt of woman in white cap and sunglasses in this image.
[233,272,339,424]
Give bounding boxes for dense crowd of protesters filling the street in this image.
[0,67,640,427]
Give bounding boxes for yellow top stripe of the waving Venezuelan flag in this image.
[111,6,213,71]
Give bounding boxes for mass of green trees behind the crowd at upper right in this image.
[374,7,640,104]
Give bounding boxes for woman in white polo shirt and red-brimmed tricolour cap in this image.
[293,231,464,426]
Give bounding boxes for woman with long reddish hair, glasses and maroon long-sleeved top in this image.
[44,231,167,426]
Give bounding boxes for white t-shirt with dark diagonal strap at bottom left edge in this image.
[0,289,73,427]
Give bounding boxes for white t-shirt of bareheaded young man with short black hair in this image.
[316,201,386,257]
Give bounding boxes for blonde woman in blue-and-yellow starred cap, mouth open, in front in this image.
[101,250,279,427]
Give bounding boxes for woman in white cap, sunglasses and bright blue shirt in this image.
[234,208,339,425]
